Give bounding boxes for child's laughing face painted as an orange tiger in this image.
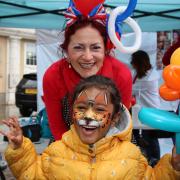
[73,87,114,144]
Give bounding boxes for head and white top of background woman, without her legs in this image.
[131,50,160,108]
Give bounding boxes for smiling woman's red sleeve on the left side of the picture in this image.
[43,62,67,140]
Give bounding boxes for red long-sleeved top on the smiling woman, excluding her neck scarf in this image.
[43,56,132,140]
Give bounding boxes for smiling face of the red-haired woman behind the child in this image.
[67,26,105,78]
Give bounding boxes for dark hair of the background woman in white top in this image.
[131,50,152,78]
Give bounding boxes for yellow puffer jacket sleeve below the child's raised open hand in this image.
[5,137,48,180]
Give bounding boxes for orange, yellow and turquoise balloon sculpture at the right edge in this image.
[138,48,180,154]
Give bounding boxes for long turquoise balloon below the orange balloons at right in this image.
[138,108,180,154]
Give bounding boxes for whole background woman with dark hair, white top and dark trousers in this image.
[131,50,160,165]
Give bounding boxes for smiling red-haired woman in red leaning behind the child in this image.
[43,18,132,140]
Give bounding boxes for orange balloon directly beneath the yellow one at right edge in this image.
[163,65,180,91]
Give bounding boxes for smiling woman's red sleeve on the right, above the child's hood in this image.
[113,58,132,109]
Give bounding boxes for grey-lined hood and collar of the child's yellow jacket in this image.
[62,106,132,156]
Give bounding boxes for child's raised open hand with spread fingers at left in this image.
[0,117,23,149]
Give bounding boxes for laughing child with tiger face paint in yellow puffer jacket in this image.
[1,76,180,180]
